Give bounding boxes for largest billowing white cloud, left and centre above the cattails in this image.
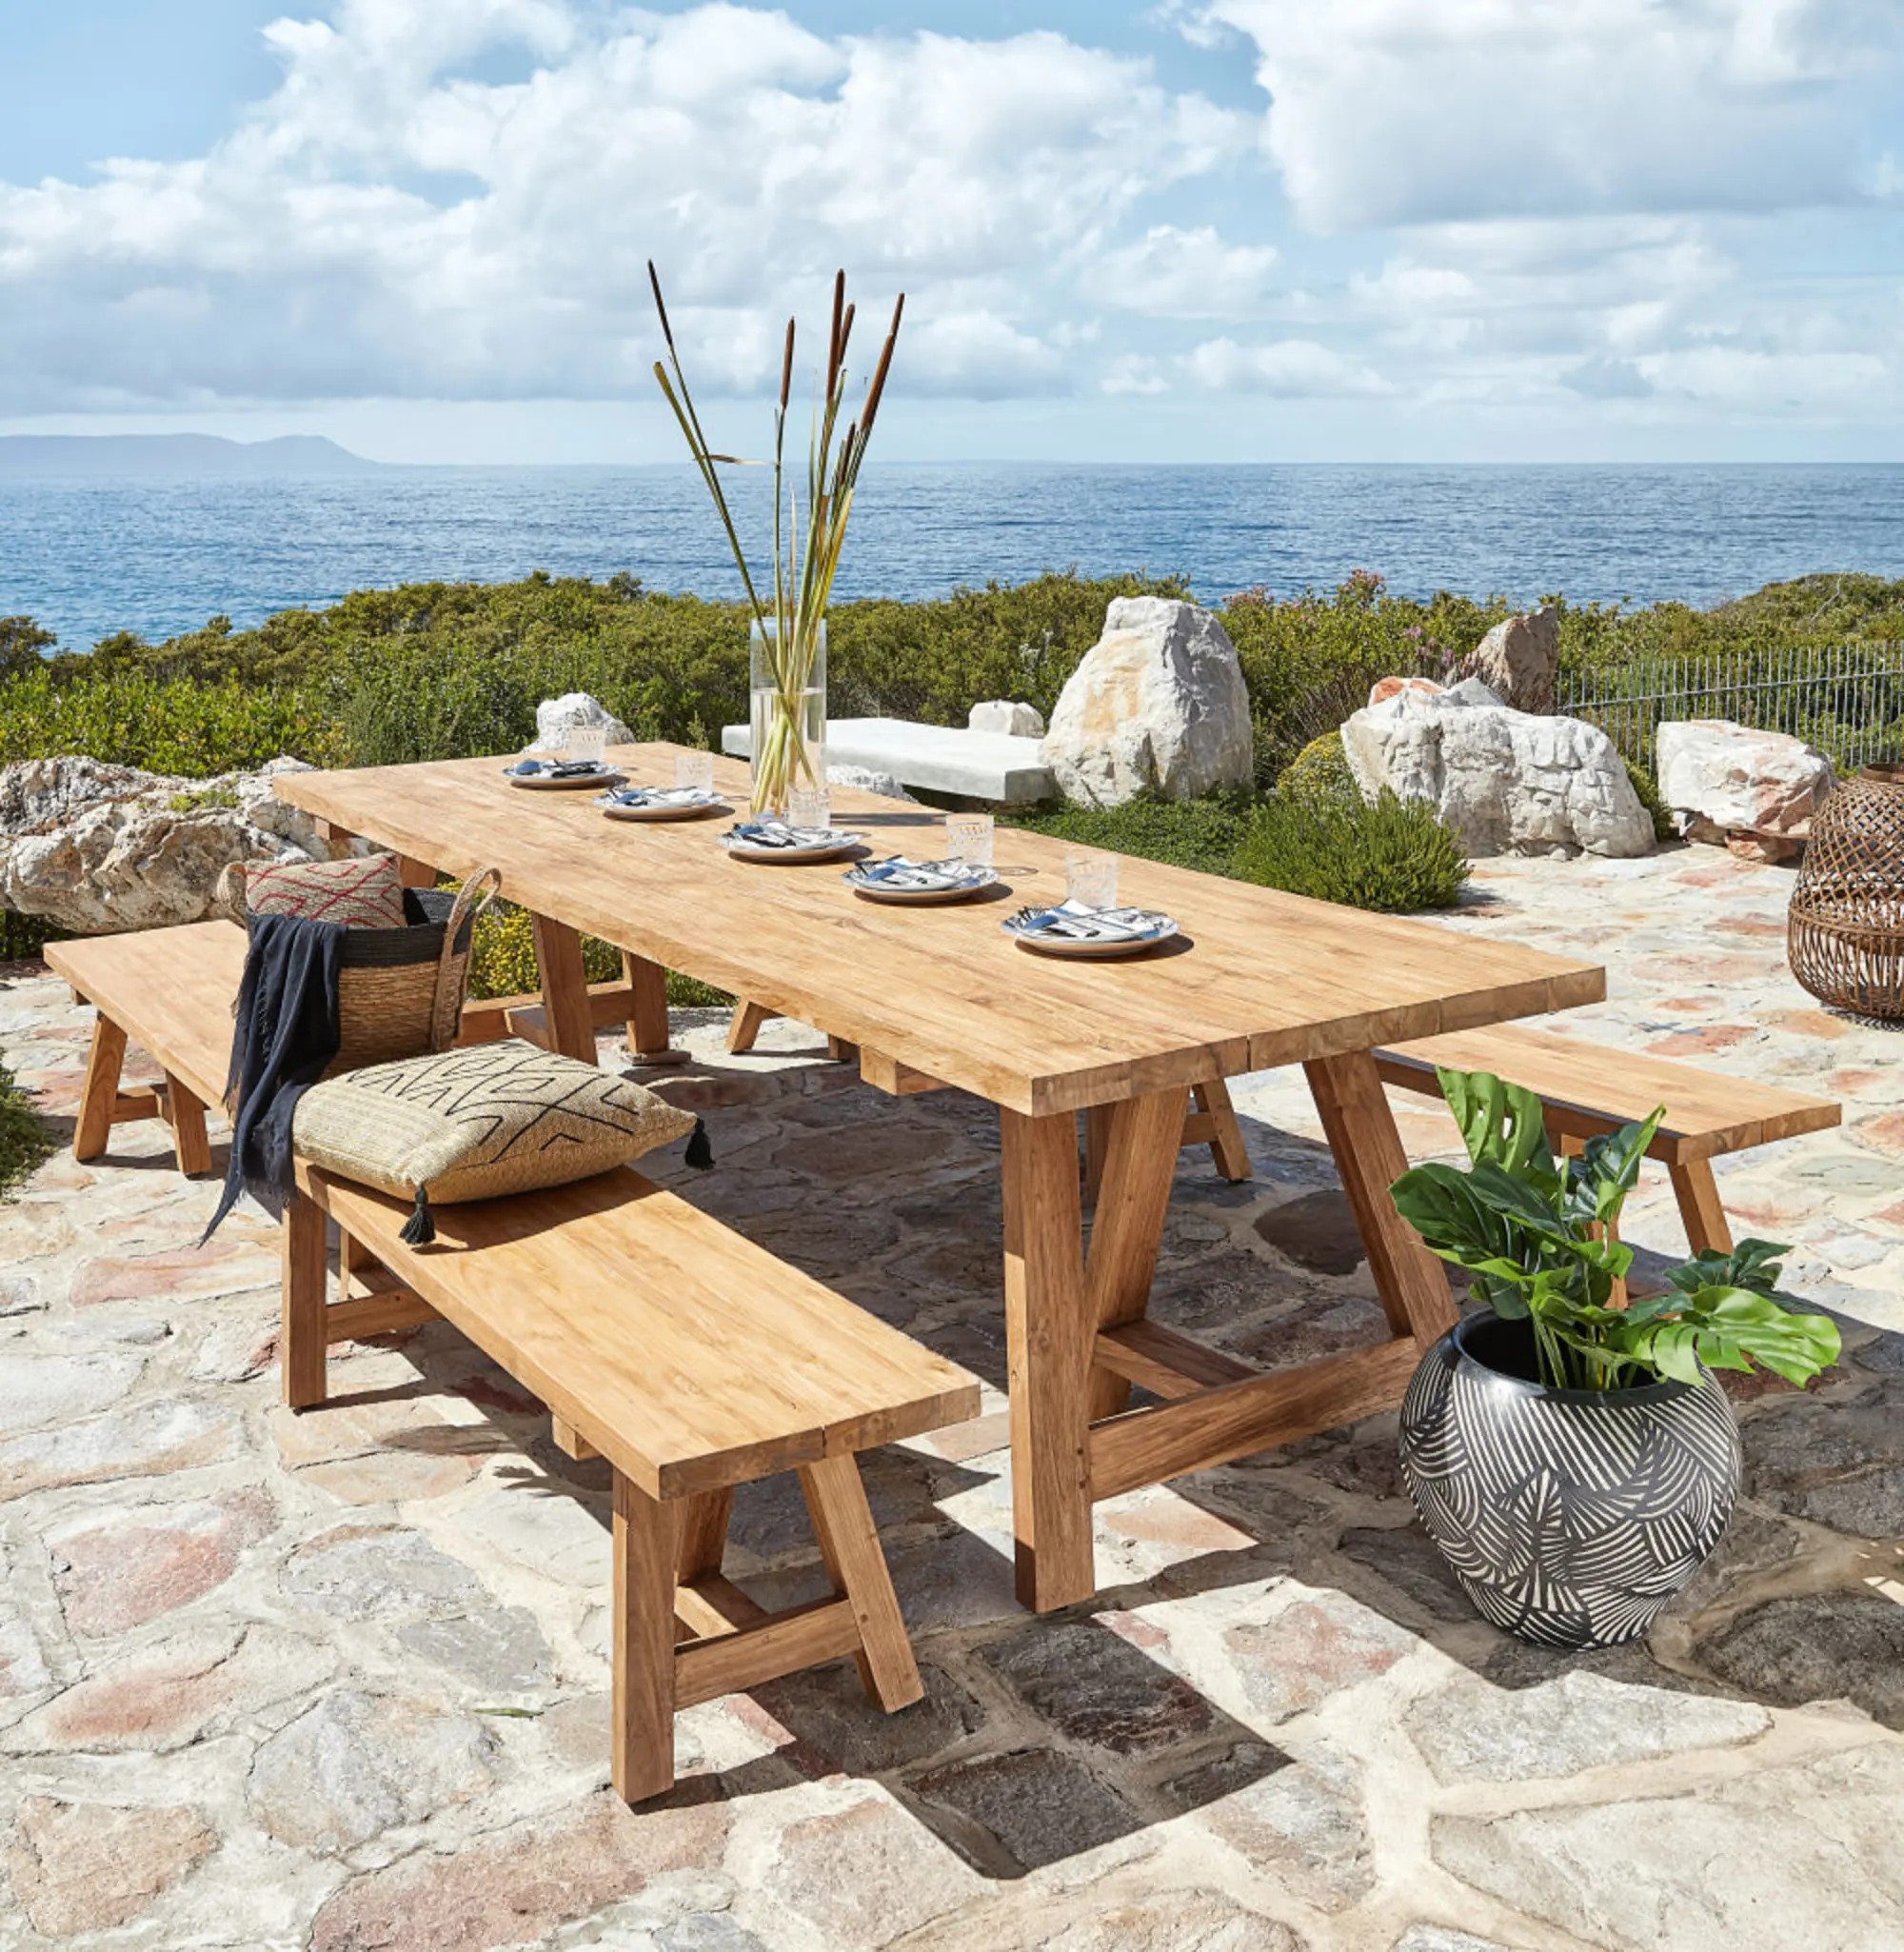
[0,0,1248,412]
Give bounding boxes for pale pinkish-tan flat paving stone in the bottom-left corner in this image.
[6,1796,219,1939]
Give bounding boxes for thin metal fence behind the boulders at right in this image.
[1558,645,1904,773]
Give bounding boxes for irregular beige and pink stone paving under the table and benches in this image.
[0,851,1904,1952]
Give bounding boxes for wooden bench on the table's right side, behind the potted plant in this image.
[1376,1023,1841,1253]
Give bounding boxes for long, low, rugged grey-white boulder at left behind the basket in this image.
[0,759,329,935]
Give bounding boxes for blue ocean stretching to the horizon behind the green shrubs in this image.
[0,463,1904,648]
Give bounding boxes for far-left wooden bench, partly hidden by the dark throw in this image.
[45,922,244,1173]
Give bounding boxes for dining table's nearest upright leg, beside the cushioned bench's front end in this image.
[999,1110,1097,1612]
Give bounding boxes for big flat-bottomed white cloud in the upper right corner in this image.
[1198,0,1904,230]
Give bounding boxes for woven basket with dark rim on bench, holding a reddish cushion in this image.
[221,866,502,1078]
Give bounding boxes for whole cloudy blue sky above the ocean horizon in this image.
[0,0,1904,463]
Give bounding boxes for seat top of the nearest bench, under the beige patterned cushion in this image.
[301,1167,978,1499]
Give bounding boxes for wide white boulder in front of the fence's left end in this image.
[1342,694,1653,857]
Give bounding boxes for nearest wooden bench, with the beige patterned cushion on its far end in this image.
[281,1167,980,1802]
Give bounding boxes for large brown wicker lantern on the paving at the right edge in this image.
[1787,766,1904,1021]
